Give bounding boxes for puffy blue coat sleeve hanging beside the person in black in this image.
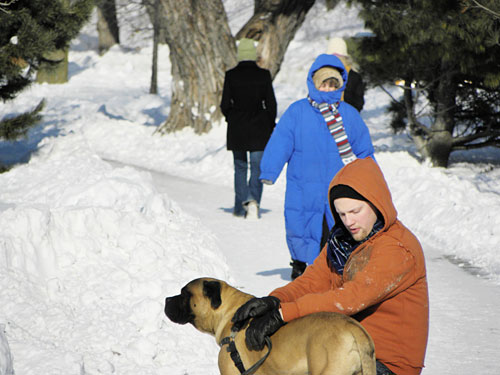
[260,108,296,183]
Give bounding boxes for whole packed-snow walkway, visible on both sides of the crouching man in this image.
[126,165,500,375]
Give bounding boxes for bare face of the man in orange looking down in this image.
[333,198,377,241]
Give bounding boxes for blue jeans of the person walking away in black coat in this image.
[233,151,264,215]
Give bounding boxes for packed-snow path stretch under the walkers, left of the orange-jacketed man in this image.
[146,168,291,296]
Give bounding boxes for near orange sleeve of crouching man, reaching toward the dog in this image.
[273,245,416,321]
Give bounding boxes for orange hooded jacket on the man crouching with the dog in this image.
[271,158,429,375]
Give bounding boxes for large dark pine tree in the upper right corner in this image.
[349,0,500,167]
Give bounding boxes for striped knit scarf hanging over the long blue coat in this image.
[307,96,356,165]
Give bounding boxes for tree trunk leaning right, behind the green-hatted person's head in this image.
[236,0,314,78]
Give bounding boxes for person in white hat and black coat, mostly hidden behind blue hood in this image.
[326,38,365,112]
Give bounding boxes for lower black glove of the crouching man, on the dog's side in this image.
[245,309,285,350]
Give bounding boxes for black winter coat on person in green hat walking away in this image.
[220,61,277,151]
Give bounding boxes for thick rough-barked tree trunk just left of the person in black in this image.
[158,0,236,133]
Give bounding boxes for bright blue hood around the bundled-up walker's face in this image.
[307,54,347,104]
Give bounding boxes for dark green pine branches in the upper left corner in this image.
[0,0,93,150]
